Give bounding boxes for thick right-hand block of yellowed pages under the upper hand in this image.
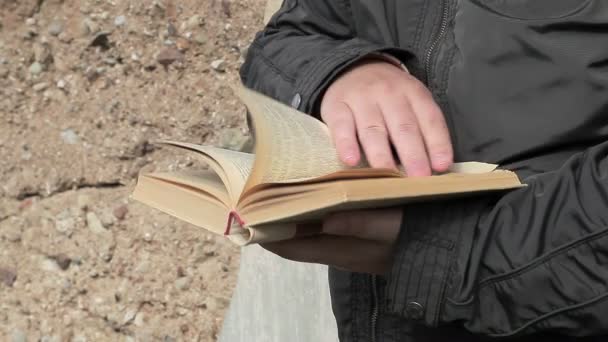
[239,170,524,226]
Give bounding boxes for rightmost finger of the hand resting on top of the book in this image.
[408,82,454,172]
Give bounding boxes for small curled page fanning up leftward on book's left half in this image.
[163,141,254,204]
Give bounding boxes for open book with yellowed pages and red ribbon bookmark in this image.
[133,87,522,245]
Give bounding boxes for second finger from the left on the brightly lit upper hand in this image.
[351,97,397,169]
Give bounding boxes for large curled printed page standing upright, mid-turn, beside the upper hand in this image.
[236,87,348,189]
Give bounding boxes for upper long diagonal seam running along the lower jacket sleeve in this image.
[448,229,608,306]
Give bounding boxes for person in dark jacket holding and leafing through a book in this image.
[241,0,608,342]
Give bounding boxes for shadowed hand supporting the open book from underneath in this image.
[262,209,403,274]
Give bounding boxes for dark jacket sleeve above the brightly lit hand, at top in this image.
[241,0,408,113]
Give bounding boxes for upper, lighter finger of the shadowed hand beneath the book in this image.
[322,209,403,244]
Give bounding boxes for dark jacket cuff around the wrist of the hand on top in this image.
[291,38,411,116]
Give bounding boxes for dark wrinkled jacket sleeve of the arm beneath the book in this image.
[387,142,608,337]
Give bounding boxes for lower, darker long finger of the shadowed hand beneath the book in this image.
[262,235,392,274]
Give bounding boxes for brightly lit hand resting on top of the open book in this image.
[321,60,453,176]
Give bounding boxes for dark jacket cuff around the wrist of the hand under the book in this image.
[386,199,487,327]
